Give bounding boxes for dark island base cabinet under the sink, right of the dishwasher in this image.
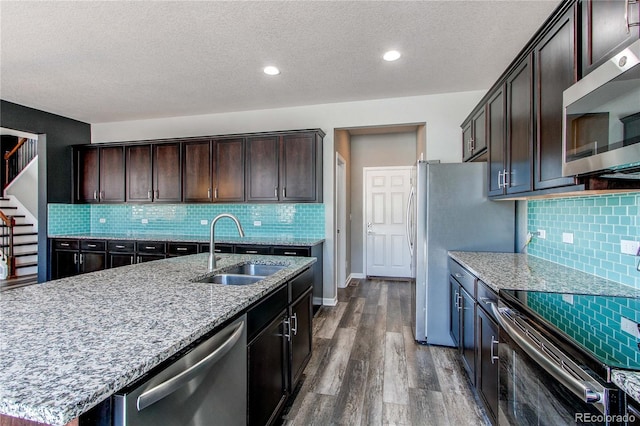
[247,268,313,426]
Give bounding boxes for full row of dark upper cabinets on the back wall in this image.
[74,129,324,203]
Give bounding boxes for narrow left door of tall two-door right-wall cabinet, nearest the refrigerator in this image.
[487,87,506,196]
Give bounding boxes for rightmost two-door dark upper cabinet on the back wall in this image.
[246,132,324,202]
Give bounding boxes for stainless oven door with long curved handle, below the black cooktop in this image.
[493,305,620,425]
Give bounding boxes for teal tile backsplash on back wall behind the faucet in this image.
[48,204,325,239]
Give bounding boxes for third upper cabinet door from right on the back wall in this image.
[213,139,244,202]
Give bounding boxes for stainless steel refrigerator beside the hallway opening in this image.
[407,161,515,346]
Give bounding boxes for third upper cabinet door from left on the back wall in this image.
[126,145,153,202]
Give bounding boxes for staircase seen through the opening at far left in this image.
[0,198,38,279]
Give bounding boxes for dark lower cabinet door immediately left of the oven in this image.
[476,309,500,424]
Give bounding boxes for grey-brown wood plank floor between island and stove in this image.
[283,280,489,426]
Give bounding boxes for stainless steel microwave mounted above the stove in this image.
[562,40,640,176]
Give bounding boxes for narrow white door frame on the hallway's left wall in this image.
[335,152,347,288]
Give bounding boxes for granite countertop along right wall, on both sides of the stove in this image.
[449,251,640,402]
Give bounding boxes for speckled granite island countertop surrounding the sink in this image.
[0,253,316,425]
